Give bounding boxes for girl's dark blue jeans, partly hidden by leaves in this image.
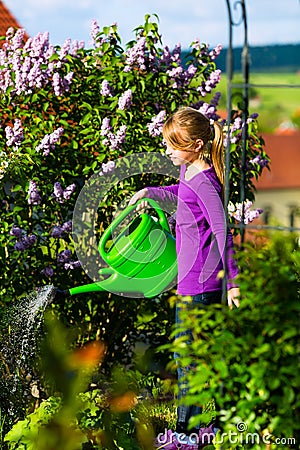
[174,291,222,433]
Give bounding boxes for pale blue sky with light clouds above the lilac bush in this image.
[3,0,300,49]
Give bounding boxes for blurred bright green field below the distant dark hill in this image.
[213,72,300,132]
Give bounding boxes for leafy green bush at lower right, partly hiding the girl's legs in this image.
[172,235,300,449]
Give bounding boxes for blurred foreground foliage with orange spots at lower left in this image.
[4,313,175,450]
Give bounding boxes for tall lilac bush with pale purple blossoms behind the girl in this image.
[0,16,269,298]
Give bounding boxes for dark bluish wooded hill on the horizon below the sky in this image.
[216,44,300,72]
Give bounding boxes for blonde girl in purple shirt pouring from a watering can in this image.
[130,108,239,450]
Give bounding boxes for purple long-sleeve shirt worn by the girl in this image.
[147,165,238,295]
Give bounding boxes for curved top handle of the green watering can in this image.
[99,197,171,254]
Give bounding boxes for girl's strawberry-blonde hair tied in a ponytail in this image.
[163,107,224,185]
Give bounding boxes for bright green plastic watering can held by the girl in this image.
[59,198,177,298]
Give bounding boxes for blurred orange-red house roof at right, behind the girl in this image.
[255,131,300,190]
